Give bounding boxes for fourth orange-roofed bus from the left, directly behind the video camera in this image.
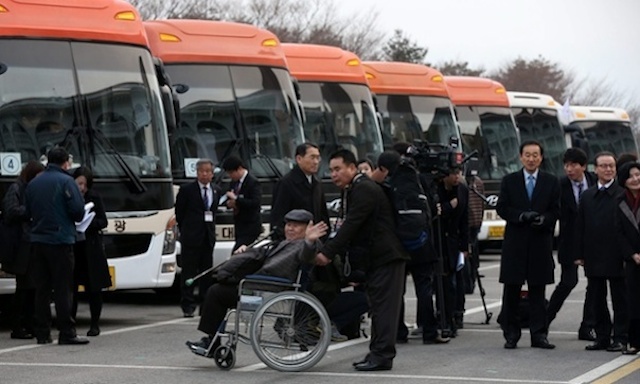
[363,61,460,148]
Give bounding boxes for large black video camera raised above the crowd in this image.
[406,138,464,177]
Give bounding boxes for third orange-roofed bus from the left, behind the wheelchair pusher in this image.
[282,44,383,188]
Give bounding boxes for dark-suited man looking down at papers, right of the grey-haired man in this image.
[222,156,262,252]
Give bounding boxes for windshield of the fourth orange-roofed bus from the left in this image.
[378,95,460,147]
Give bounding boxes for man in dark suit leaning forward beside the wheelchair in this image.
[316,149,410,371]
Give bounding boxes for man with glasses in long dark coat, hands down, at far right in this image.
[576,152,628,352]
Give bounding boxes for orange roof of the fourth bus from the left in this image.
[362,61,449,98]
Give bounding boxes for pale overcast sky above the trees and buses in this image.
[335,0,640,104]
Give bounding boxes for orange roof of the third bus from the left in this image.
[282,43,368,85]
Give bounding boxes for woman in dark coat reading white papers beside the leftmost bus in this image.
[73,167,111,336]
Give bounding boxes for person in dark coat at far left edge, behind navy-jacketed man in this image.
[2,160,44,339]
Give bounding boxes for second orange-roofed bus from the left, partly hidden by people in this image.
[144,20,304,264]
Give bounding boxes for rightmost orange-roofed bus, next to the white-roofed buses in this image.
[444,76,522,241]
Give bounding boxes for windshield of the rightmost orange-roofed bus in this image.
[456,106,521,180]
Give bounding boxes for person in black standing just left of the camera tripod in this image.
[434,167,469,337]
